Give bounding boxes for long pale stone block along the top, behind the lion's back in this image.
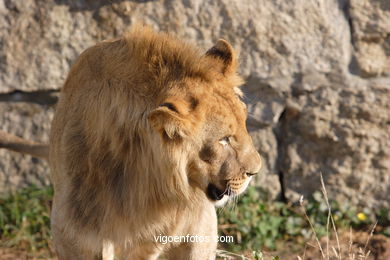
[0,0,350,92]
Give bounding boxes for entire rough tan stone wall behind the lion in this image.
[0,0,390,208]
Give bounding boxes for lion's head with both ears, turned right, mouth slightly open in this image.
[149,40,261,205]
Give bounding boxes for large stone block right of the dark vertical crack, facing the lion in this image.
[278,75,390,207]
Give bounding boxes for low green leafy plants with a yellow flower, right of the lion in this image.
[218,187,390,255]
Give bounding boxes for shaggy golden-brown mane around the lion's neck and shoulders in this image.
[51,28,219,250]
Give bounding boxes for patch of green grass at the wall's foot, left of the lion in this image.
[0,186,53,251]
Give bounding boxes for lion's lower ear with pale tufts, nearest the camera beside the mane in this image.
[149,102,188,140]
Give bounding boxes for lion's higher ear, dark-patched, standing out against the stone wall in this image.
[206,39,238,74]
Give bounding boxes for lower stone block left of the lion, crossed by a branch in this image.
[0,103,54,193]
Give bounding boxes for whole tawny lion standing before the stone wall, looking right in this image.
[0,27,262,260]
